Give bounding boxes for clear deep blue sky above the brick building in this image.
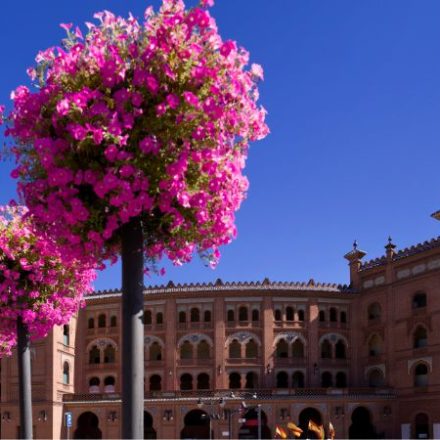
[0,0,440,288]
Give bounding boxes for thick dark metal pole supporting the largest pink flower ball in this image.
[121,217,144,439]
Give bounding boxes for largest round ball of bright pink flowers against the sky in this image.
[7,0,268,265]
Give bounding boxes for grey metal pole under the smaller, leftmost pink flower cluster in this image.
[17,317,32,440]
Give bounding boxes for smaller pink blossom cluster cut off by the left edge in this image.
[0,206,95,357]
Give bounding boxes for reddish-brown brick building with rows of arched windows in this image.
[0,238,440,438]
